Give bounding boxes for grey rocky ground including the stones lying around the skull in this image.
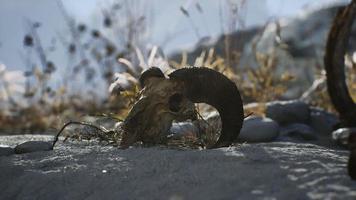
[0,101,356,200]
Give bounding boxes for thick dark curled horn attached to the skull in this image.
[169,67,244,148]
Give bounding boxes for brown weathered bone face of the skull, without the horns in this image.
[121,74,196,148]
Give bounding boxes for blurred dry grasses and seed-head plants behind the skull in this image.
[0,1,356,147]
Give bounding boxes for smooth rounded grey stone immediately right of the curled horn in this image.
[238,117,279,142]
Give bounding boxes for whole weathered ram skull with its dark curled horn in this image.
[120,67,244,148]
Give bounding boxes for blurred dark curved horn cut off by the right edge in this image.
[324,0,356,126]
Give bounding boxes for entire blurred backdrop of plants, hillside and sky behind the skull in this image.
[0,0,356,134]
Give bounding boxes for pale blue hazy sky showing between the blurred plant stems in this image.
[0,0,347,69]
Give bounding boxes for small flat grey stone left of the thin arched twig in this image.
[15,141,52,154]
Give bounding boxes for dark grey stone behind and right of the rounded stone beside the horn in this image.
[266,100,310,125]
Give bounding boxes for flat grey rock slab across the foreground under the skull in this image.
[0,136,356,200]
